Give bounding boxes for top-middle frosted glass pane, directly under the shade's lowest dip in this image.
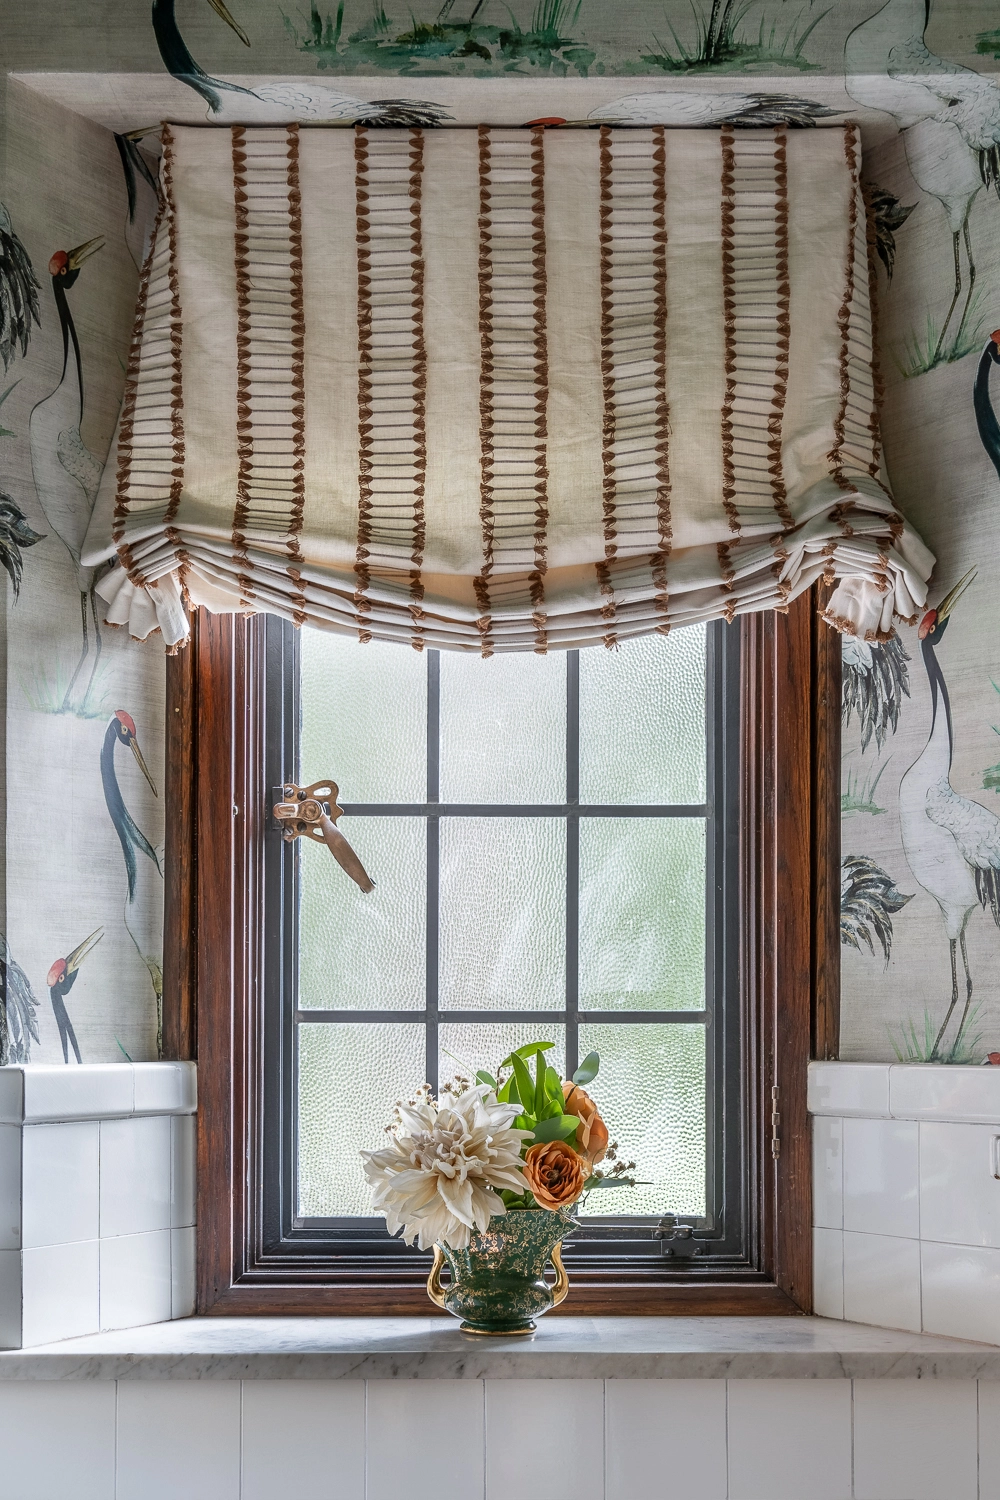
[441,651,567,803]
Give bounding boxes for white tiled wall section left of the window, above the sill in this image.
[0,1062,196,1349]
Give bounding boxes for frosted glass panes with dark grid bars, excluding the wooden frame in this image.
[284,624,739,1263]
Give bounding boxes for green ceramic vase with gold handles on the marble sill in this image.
[427,1209,576,1338]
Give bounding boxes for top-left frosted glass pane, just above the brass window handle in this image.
[300,626,427,803]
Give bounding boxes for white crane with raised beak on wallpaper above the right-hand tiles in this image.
[900,569,1000,1062]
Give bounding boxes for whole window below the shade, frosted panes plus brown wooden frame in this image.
[177,588,838,1313]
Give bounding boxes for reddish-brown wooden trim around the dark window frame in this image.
[163,591,840,1316]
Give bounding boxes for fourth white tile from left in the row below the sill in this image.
[366,1380,485,1500]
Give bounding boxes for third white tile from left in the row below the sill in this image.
[240,1380,365,1500]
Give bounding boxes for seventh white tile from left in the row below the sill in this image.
[729,1380,851,1500]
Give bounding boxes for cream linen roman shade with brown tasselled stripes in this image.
[84,126,934,654]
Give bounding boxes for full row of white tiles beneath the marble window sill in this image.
[0,1379,1000,1500]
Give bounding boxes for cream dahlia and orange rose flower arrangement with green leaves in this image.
[361,1041,636,1250]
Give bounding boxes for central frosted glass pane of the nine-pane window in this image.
[439,818,565,1011]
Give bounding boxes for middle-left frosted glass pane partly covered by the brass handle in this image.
[298,816,427,1031]
